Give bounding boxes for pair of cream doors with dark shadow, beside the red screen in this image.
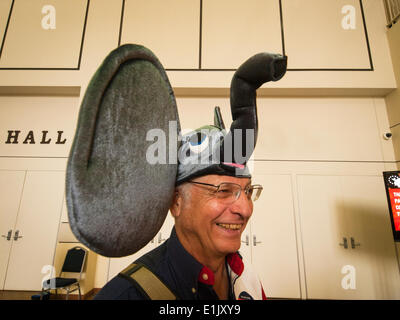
[298,175,400,299]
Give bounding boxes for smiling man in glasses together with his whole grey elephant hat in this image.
[66,45,286,299]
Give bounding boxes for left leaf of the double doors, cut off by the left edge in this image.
[0,170,25,290]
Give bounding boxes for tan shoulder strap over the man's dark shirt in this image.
[120,263,176,300]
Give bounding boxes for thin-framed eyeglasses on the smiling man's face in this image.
[188,181,263,203]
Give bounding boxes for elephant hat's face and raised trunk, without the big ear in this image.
[177,53,287,185]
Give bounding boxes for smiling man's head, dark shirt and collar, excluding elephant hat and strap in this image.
[96,170,265,300]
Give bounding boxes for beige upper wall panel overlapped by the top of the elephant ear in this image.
[121,0,200,69]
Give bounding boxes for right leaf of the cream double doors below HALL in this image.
[4,171,65,291]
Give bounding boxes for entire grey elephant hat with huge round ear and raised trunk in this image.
[66,44,286,257]
